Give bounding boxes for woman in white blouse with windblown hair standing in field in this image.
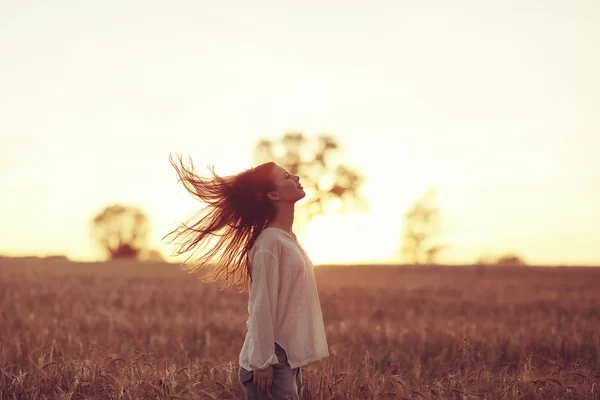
[167,157,329,399]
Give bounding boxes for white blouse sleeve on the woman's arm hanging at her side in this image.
[248,250,279,370]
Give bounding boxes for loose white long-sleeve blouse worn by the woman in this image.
[239,228,329,371]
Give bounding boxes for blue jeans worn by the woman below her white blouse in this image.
[238,343,302,400]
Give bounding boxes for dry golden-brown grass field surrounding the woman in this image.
[0,259,600,399]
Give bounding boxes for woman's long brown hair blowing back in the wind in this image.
[163,155,276,291]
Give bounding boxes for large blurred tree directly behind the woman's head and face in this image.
[254,132,367,231]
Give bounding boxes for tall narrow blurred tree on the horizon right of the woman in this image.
[401,189,446,264]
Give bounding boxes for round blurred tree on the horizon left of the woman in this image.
[92,204,148,259]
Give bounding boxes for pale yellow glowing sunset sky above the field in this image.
[0,0,600,265]
